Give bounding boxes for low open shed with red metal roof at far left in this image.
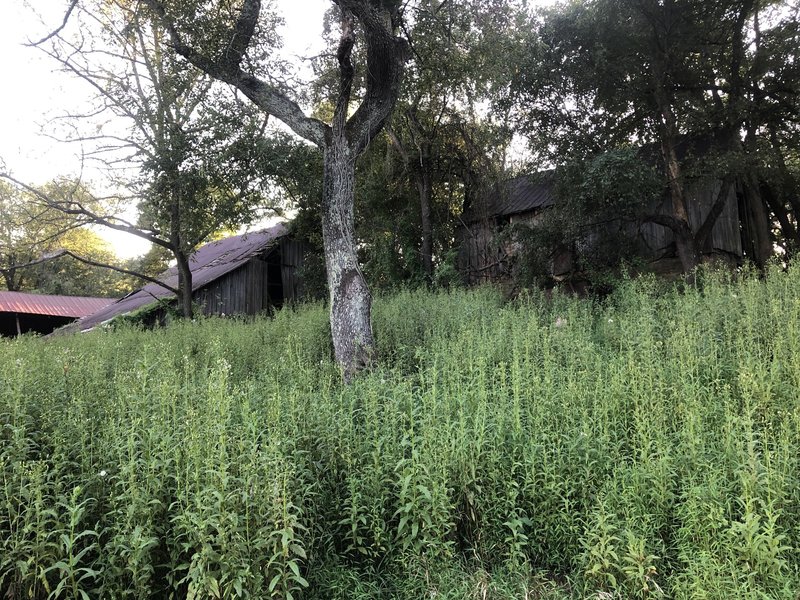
[0,292,114,337]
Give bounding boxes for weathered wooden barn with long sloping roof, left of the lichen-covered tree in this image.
[70,224,305,331]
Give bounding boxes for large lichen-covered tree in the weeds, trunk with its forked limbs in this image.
[143,0,409,380]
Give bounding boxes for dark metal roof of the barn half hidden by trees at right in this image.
[464,171,555,223]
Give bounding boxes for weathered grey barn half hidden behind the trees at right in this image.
[458,172,743,284]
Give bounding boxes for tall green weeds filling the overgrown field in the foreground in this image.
[0,267,800,600]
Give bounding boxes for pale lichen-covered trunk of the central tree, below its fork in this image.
[322,136,375,381]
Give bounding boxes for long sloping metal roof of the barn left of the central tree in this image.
[75,223,288,331]
